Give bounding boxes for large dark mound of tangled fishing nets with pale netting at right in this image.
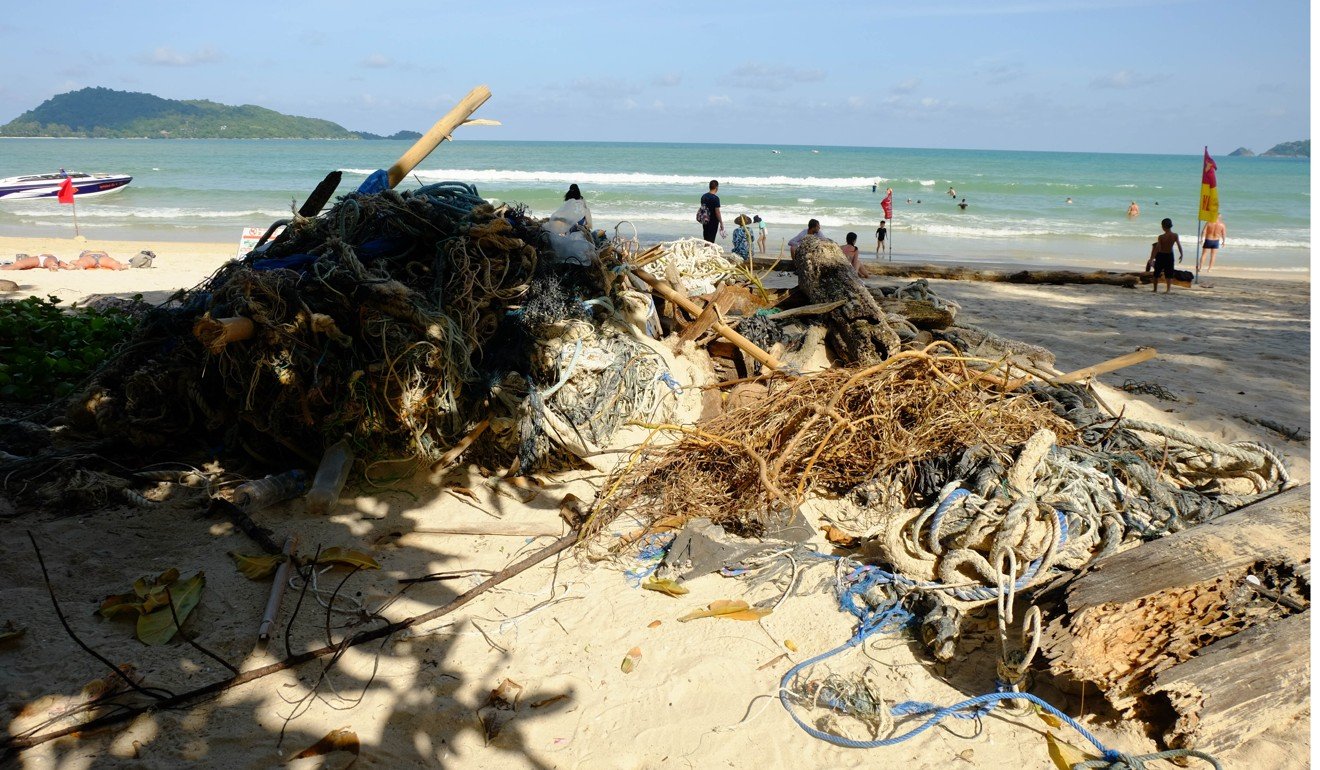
[56,182,668,472]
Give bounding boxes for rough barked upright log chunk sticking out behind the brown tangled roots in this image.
[793,238,902,366]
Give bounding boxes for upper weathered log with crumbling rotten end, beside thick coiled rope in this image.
[1040,485,1311,712]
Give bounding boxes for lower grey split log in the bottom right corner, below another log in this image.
[1151,610,1311,754]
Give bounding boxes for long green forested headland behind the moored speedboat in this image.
[0,87,421,140]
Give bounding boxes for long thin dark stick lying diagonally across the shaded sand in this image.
[0,530,578,759]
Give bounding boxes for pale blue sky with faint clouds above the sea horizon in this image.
[0,0,1311,155]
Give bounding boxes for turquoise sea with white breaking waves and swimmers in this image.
[0,139,1311,272]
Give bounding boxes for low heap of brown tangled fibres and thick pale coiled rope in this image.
[591,342,1288,606]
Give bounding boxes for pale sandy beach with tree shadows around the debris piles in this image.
[0,238,1311,770]
